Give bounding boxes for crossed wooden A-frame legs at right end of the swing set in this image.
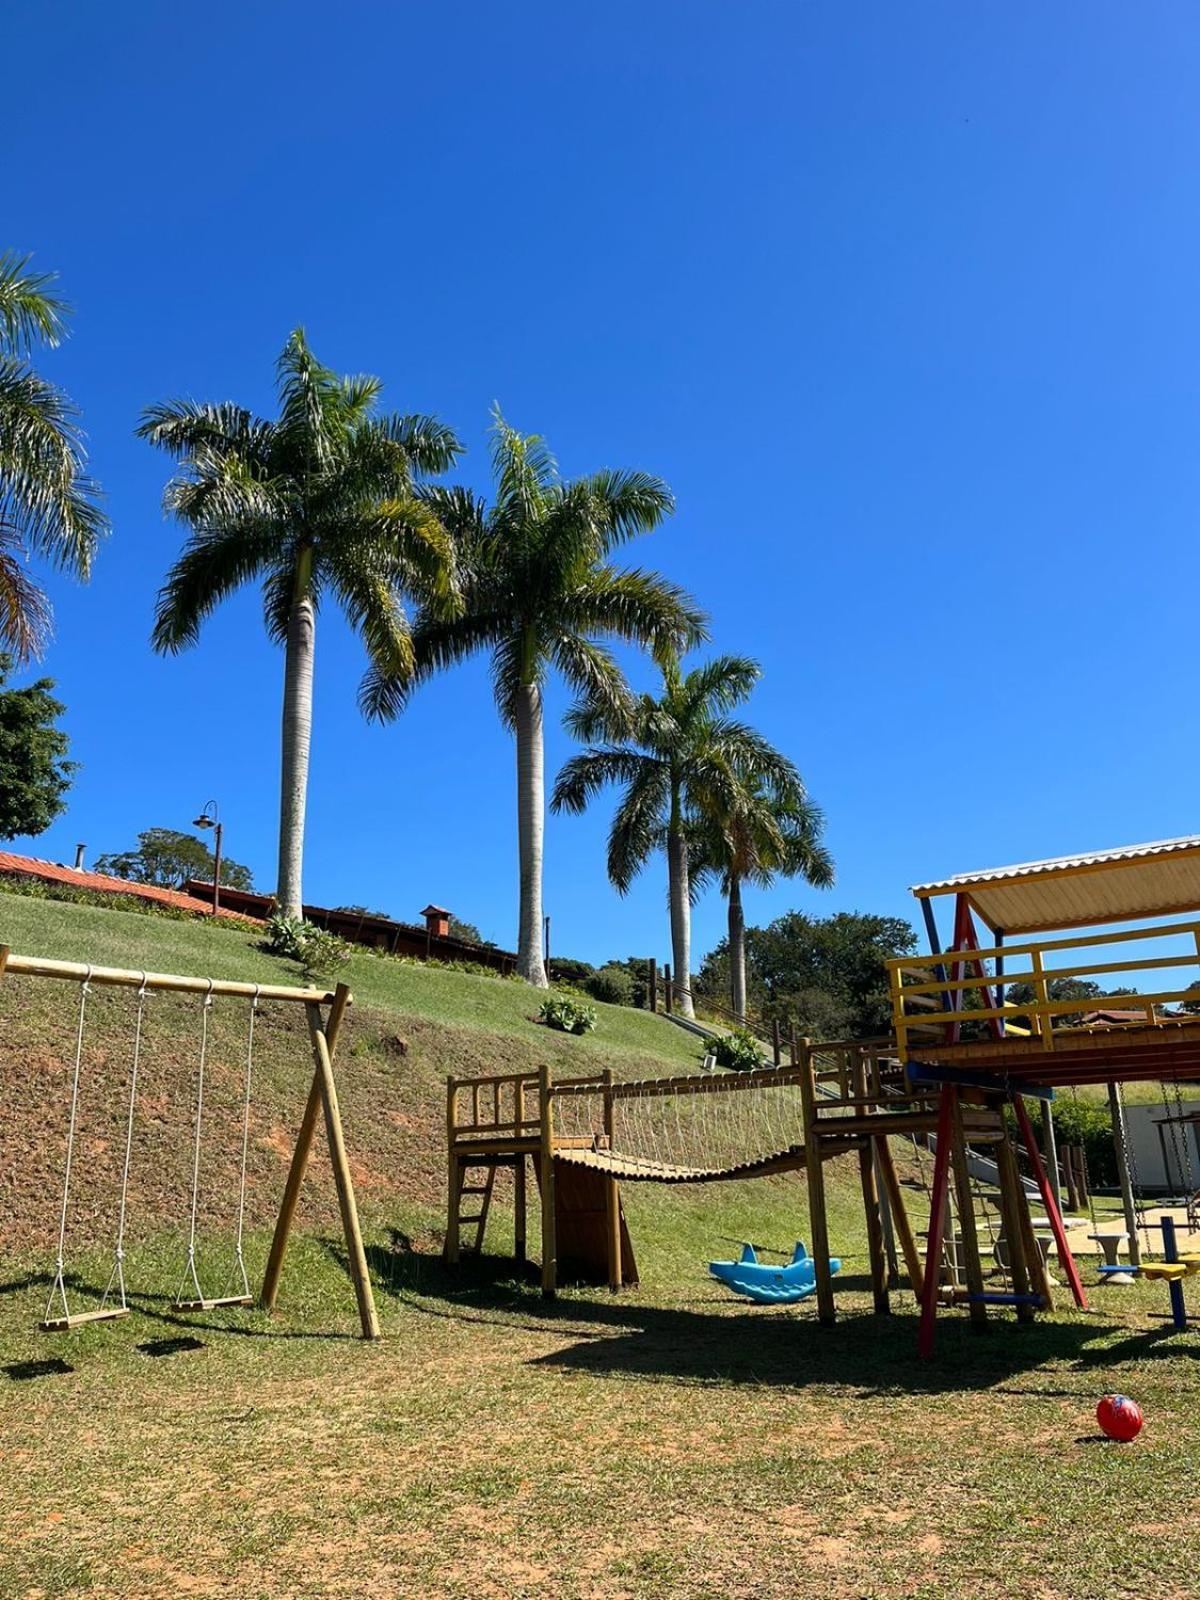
[261,984,381,1339]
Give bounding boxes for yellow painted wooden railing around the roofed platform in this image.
[888,922,1200,1061]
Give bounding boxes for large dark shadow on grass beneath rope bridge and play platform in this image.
[368,1235,1171,1398]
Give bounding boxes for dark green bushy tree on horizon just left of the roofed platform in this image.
[696,910,917,1040]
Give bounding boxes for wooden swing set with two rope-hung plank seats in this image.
[0,946,379,1339]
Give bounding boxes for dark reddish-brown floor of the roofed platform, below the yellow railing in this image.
[910,1018,1200,1088]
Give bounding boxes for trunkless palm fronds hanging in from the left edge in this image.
[0,251,109,662]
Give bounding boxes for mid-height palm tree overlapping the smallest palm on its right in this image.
[550,656,798,1016]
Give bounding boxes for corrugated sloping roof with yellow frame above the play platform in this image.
[912,834,1200,934]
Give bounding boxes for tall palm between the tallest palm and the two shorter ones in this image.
[362,410,704,989]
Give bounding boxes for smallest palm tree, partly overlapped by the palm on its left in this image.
[693,768,834,1022]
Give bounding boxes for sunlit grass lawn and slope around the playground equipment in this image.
[0,896,1200,1600]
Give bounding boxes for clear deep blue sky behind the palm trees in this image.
[0,0,1200,960]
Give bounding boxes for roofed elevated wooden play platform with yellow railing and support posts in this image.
[888,835,1200,1354]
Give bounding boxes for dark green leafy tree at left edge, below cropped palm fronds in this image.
[0,651,78,838]
